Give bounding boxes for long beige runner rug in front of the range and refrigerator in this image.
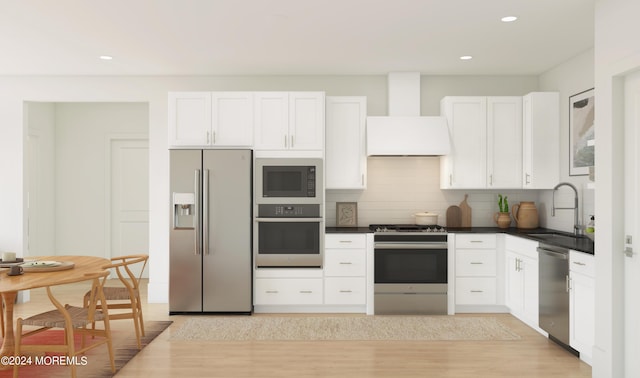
[170,315,520,341]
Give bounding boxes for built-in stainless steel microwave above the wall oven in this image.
[254,158,324,204]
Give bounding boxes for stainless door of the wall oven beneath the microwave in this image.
[254,218,324,268]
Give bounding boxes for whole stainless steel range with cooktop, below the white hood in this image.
[371,225,448,315]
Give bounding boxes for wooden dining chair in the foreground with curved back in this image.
[13,270,116,378]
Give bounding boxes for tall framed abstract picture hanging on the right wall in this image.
[569,88,595,176]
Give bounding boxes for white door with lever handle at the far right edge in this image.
[624,71,640,377]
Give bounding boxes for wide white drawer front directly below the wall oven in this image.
[254,278,322,305]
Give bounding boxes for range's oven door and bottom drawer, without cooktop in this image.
[374,242,448,315]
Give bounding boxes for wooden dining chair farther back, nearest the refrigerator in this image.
[85,254,149,349]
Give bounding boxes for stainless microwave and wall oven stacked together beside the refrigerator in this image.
[253,158,325,268]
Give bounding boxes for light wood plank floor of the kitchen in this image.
[10,285,591,378]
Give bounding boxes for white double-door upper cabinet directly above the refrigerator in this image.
[169,92,253,147]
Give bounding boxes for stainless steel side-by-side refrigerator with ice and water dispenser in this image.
[169,150,253,314]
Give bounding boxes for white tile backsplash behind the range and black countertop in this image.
[326,157,539,227]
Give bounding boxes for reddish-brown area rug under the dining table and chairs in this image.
[0,321,172,378]
